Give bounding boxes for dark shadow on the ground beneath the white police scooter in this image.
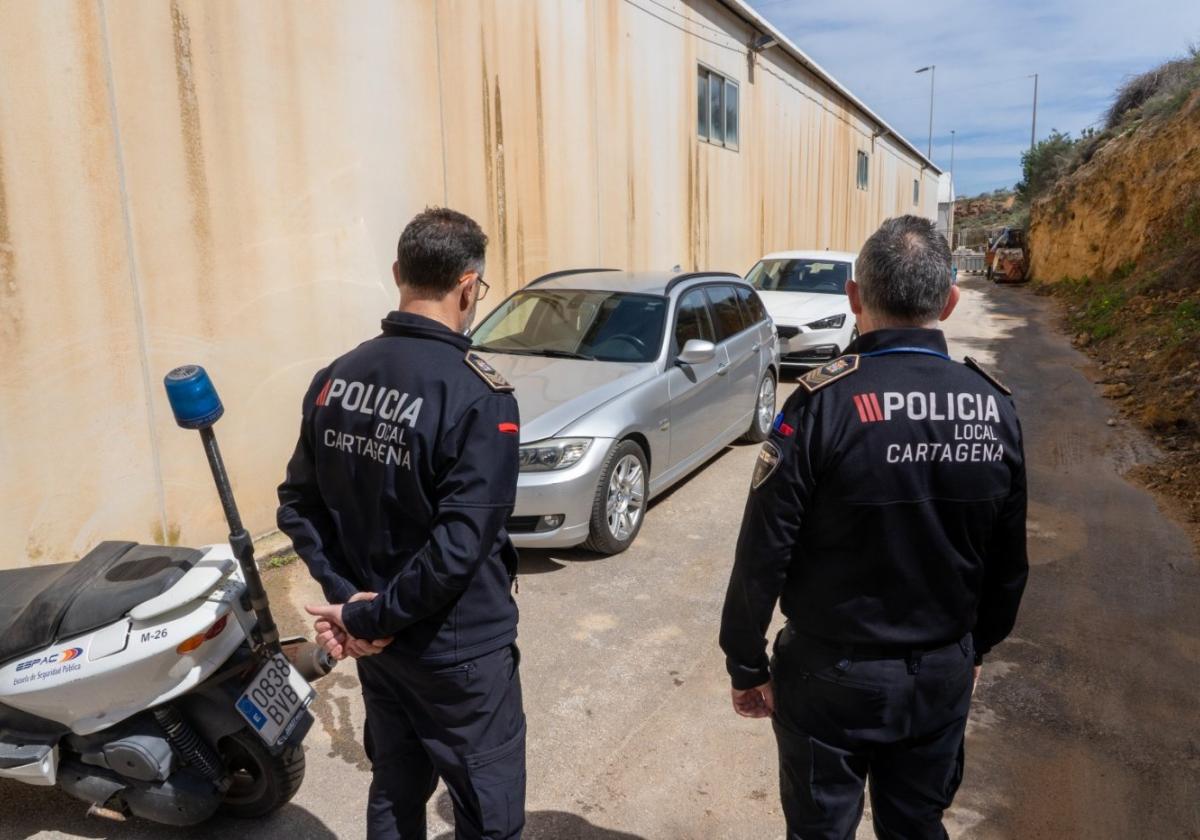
[0,780,338,840]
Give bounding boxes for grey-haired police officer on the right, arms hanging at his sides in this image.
[720,216,1028,840]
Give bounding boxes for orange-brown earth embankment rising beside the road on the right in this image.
[1030,86,1200,545]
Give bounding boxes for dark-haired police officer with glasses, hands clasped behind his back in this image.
[278,209,526,840]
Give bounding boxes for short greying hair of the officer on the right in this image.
[854,216,952,324]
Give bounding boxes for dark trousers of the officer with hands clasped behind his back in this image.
[358,644,526,840]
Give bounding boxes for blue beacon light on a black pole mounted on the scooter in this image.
[163,365,281,656]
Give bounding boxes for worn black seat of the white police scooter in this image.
[0,542,203,664]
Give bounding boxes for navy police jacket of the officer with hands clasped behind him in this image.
[277,312,520,664]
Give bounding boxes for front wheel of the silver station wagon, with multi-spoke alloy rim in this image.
[584,440,648,554]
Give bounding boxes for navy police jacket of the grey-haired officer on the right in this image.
[720,329,1028,689]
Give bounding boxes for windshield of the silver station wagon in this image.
[472,289,667,362]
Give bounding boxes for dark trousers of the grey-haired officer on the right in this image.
[772,628,974,840]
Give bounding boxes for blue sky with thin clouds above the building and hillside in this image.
[749,0,1200,196]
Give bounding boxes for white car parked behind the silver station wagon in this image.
[746,251,858,367]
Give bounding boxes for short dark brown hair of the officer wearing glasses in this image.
[396,208,487,298]
